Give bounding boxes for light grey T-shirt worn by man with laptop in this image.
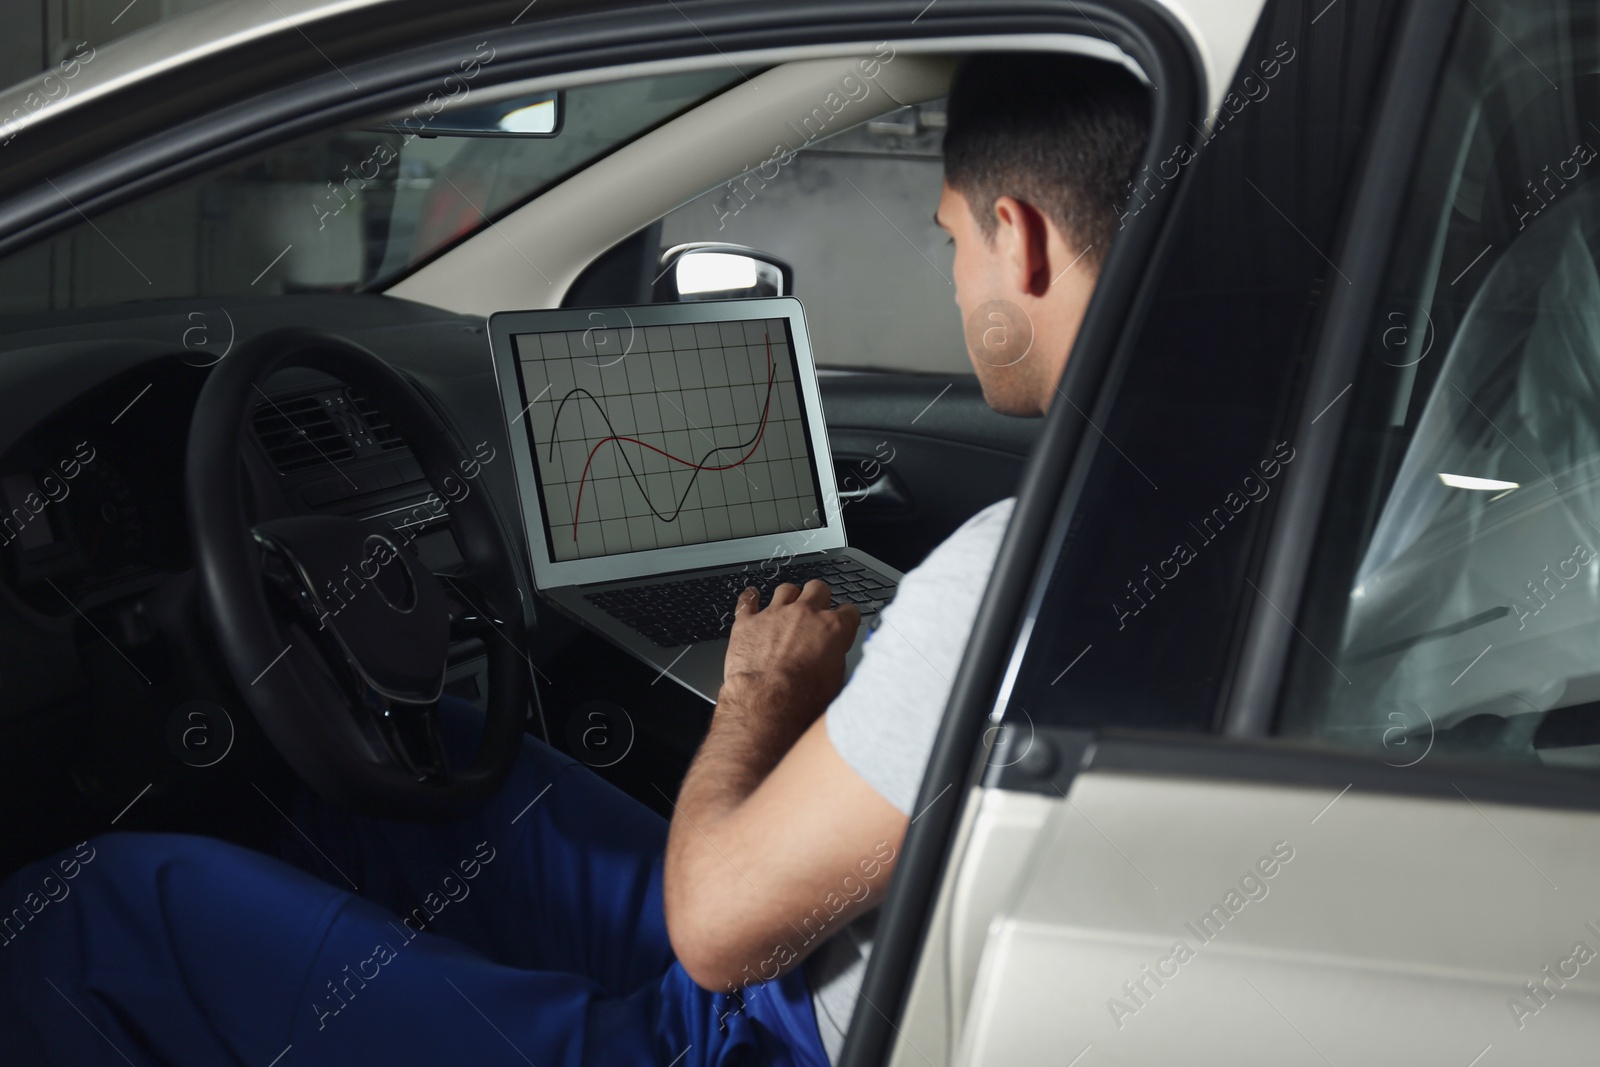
[805,499,1016,1062]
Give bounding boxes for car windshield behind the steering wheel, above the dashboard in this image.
[0,67,739,314]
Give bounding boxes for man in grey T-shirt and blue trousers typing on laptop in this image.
[0,54,1149,1067]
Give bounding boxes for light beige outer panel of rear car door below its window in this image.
[954,769,1600,1065]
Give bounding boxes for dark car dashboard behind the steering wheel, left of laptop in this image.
[0,294,533,721]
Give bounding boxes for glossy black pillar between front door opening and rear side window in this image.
[972,0,1397,737]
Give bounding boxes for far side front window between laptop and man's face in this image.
[661,101,971,376]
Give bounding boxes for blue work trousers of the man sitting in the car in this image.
[0,699,827,1067]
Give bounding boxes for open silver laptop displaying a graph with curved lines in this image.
[490,298,901,701]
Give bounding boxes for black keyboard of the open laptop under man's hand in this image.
[584,557,894,648]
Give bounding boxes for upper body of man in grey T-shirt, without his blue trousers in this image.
[666,54,1149,1061]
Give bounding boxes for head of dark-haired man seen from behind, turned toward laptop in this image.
[934,53,1150,414]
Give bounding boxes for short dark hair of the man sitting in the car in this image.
[944,53,1150,269]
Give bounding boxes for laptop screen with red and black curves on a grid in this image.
[515,318,822,560]
